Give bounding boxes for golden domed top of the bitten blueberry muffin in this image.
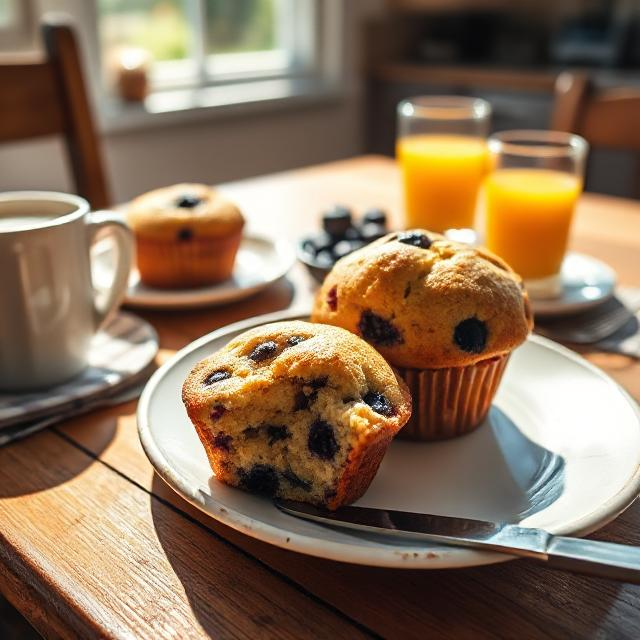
[182,321,411,440]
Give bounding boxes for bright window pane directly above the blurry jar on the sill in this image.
[98,0,193,62]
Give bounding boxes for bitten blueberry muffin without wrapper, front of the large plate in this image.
[182,322,411,509]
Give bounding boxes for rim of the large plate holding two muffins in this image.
[136,307,640,569]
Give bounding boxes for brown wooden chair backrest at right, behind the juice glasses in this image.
[551,73,640,152]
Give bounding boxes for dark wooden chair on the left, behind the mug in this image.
[0,22,110,209]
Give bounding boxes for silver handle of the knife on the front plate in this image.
[547,536,640,584]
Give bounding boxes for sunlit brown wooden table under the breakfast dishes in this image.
[0,157,640,639]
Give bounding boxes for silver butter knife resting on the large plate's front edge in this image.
[274,500,640,584]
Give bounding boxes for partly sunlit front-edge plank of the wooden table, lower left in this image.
[0,433,366,639]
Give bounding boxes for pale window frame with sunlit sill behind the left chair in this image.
[7,0,349,134]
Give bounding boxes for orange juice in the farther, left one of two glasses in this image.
[397,134,487,232]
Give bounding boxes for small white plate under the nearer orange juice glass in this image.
[531,253,616,316]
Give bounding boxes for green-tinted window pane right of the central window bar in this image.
[206,0,279,54]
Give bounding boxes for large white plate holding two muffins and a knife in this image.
[138,313,640,569]
